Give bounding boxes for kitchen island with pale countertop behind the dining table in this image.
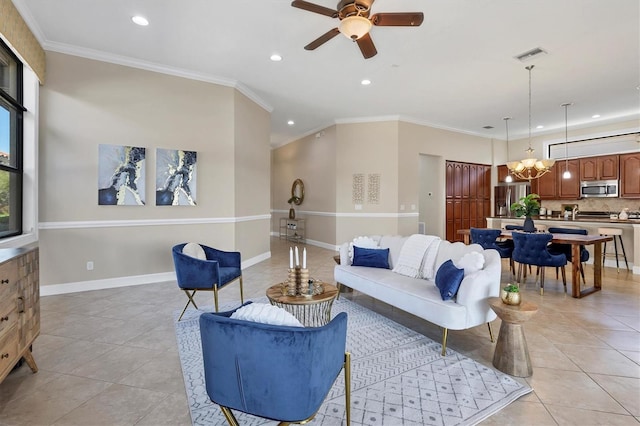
[487,214,640,274]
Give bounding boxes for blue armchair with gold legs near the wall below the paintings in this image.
[172,243,244,321]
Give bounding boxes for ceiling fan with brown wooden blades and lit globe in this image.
[291,0,424,59]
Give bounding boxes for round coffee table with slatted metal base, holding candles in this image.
[267,282,338,327]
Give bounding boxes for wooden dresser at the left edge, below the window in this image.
[0,244,40,382]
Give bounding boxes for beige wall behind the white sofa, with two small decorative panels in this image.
[272,121,494,245]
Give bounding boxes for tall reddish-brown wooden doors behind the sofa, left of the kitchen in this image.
[445,161,491,241]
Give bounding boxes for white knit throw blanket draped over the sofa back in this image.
[393,234,440,278]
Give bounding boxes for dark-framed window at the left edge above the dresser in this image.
[0,40,26,238]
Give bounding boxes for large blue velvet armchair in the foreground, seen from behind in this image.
[200,304,351,425]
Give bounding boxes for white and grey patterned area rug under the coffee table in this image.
[175,298,532,426]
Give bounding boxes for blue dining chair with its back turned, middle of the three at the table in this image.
[511,231,567,295]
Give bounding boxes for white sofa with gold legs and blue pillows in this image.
[334,236,502,356]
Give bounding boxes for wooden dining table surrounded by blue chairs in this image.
[458,229,613,299]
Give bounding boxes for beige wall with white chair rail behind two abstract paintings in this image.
[39,52,270,285]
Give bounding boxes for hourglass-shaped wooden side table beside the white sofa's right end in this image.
[489,297,538,377]
